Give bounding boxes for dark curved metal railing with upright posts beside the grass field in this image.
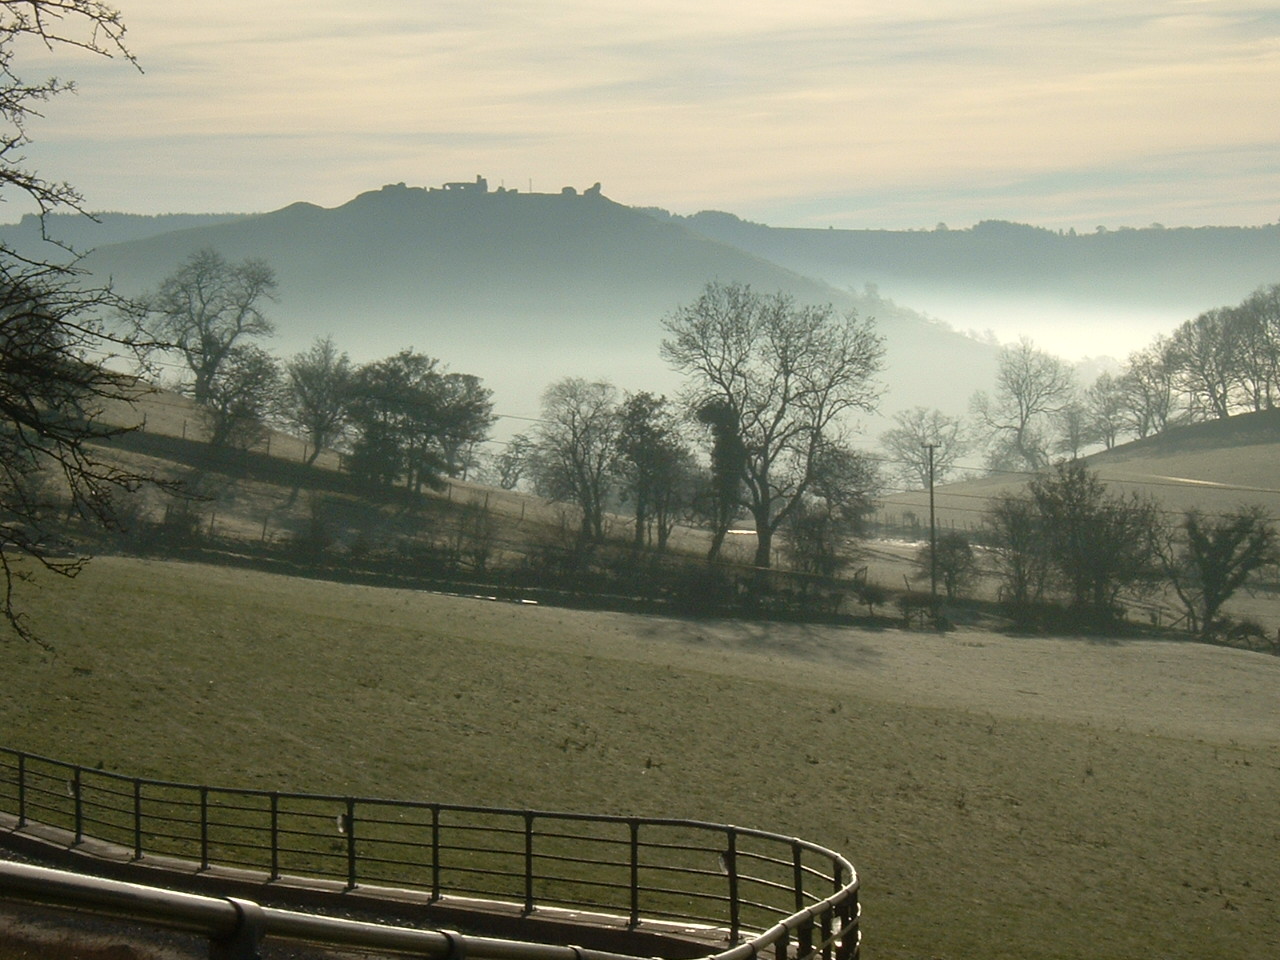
[0,748,859,960]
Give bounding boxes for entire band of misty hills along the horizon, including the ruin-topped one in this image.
[42,183,1280,434]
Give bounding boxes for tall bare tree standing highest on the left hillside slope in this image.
[138,248,275,403]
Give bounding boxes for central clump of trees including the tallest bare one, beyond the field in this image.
[498,283,882,576]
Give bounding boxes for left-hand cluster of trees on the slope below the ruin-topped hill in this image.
[131,250,494,492]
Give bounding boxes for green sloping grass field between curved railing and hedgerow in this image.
[0,558,1280,960]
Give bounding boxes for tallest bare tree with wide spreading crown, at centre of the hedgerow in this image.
[662,283,883,567]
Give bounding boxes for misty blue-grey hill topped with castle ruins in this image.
[77,184,995,427]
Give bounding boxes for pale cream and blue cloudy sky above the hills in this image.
[17,0,1280,229]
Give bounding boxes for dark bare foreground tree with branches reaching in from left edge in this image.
[0,0,160,641]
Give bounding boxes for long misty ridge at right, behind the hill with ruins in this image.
[658,212,1280,360]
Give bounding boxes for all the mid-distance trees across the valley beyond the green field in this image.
[127,251,1280,650]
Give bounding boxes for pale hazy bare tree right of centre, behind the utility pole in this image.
[972,337,1074,470]
